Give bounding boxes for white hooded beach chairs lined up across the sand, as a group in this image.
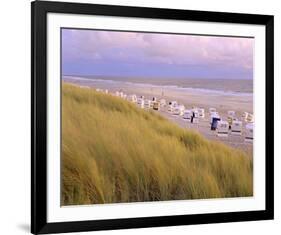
[96,89,254,142]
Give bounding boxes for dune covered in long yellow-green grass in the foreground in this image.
[61,84,253,205]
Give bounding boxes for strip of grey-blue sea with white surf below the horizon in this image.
[62,75,253,96]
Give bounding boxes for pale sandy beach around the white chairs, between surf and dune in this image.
[63,76,253,154]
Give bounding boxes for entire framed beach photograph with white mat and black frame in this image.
[31,1,274,234]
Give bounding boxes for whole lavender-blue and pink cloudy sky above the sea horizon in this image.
[61,29,254,79]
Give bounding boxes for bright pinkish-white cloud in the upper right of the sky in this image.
[139,35,253,68]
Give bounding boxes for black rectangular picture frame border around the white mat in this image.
[31,1,274,234]
